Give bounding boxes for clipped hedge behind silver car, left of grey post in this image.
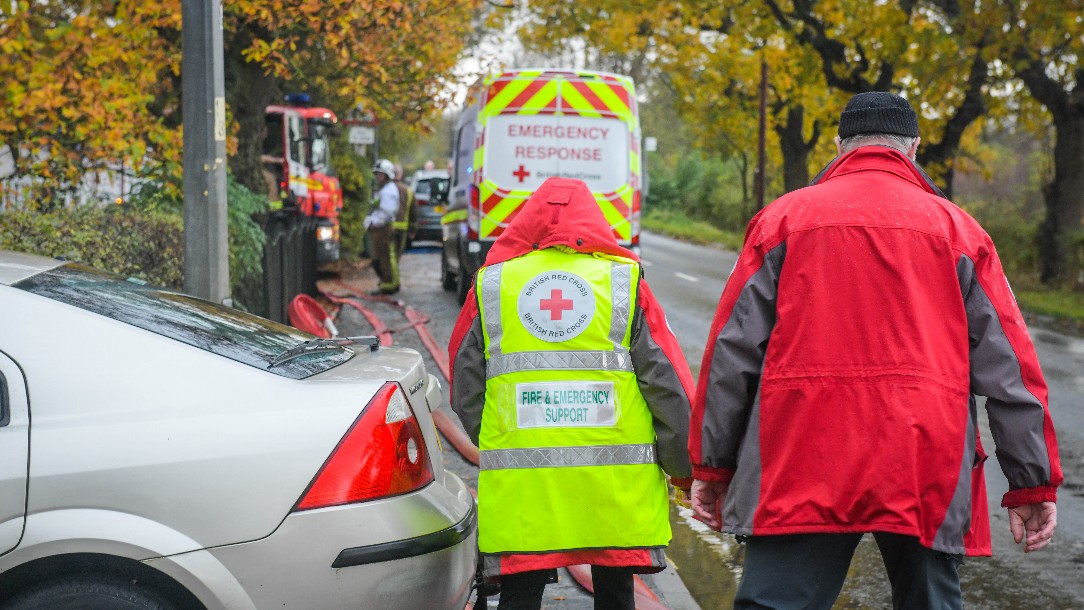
[0,206,184,288]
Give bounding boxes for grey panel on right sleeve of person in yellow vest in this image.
[630,307,693,478]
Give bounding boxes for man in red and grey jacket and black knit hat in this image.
[689,92,1062,609]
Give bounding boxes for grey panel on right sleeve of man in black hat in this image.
[956,255,1050,490]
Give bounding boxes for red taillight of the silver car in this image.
[294,382,433,510]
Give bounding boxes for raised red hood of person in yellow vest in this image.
[486,178,640,264]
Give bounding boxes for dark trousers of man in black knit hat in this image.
[734,533,964,610]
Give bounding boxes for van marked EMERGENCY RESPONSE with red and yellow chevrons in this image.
[440,69,642,302]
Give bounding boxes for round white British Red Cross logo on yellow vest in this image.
[517,271,595,342]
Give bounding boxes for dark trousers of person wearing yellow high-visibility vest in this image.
[498,566,636,610]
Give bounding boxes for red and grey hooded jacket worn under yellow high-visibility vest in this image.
[448,178,693,575]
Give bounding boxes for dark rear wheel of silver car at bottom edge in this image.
[0,574,180,610]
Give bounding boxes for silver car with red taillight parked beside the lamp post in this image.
[0,251,477,610]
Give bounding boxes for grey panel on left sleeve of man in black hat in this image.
[700,242,787,469]
